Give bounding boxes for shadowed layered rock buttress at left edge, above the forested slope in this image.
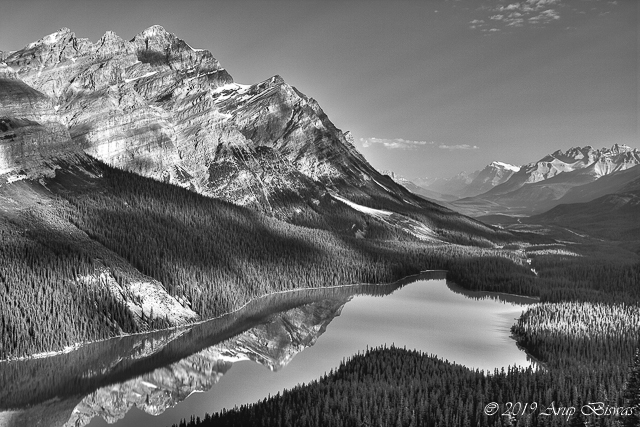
[0,63,75,176]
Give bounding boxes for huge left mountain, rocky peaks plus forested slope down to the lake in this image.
[0,26,522,359]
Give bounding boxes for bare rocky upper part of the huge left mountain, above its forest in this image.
[0,25,510,241]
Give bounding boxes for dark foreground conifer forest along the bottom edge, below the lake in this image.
[174,346,640,427]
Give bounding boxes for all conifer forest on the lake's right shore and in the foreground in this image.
[168,224,640,427]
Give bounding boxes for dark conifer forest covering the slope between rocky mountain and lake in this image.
[0,165,535,359]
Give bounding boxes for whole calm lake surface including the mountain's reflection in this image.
[0,272,535,427]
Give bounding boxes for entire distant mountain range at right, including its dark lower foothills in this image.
[383,144,640,241]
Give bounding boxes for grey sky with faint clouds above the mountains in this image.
[0,0,640,178]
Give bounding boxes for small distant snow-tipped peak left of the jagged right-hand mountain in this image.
[416,161,520,200]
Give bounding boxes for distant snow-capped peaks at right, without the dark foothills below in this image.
[420,144,640,217]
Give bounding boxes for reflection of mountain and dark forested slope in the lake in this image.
[0,272,445,427]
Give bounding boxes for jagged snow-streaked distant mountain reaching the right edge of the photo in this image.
[452,144,640,216]
